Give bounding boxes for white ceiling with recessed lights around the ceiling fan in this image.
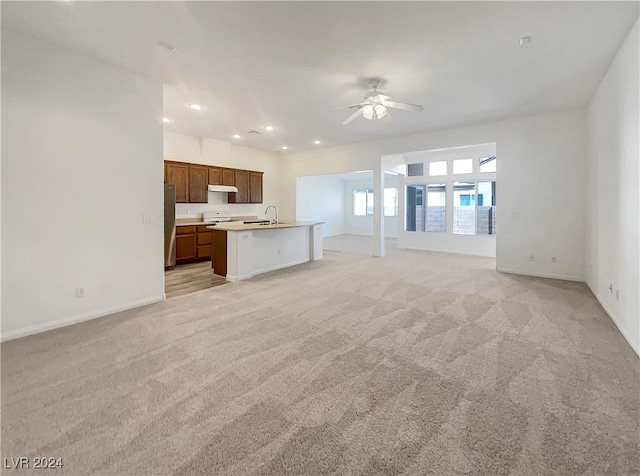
[2,1,638,151]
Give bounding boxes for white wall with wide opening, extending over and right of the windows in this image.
[283,109,587,280]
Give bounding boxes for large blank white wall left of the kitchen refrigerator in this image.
[2,29,164,339]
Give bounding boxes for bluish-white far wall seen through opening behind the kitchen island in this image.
[296,175,345,237]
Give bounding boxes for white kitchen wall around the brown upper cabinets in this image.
[164,131,281,218]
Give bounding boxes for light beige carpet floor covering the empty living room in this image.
[2,237,640,475]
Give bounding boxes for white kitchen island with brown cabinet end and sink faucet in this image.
[207,221,322,281]
